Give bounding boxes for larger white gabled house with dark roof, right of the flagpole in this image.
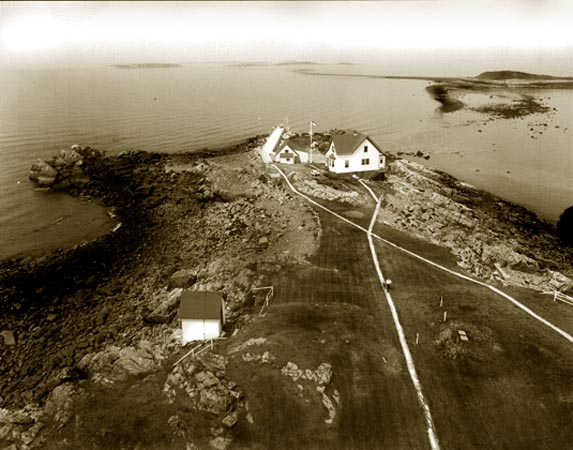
[325,131,386,173]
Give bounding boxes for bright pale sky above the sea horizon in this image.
[0,0,573,75]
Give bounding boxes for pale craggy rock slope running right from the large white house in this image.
[379,160,573,290]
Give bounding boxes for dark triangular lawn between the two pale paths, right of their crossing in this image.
[375,229,573,449]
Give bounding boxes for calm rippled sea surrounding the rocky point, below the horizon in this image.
[0,64,573,258]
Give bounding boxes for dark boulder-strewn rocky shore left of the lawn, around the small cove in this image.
[0,139,319,448]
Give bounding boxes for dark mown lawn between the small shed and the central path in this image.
[223,212,428,449]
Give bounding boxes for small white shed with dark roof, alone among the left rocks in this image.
[179,289,225,344]
